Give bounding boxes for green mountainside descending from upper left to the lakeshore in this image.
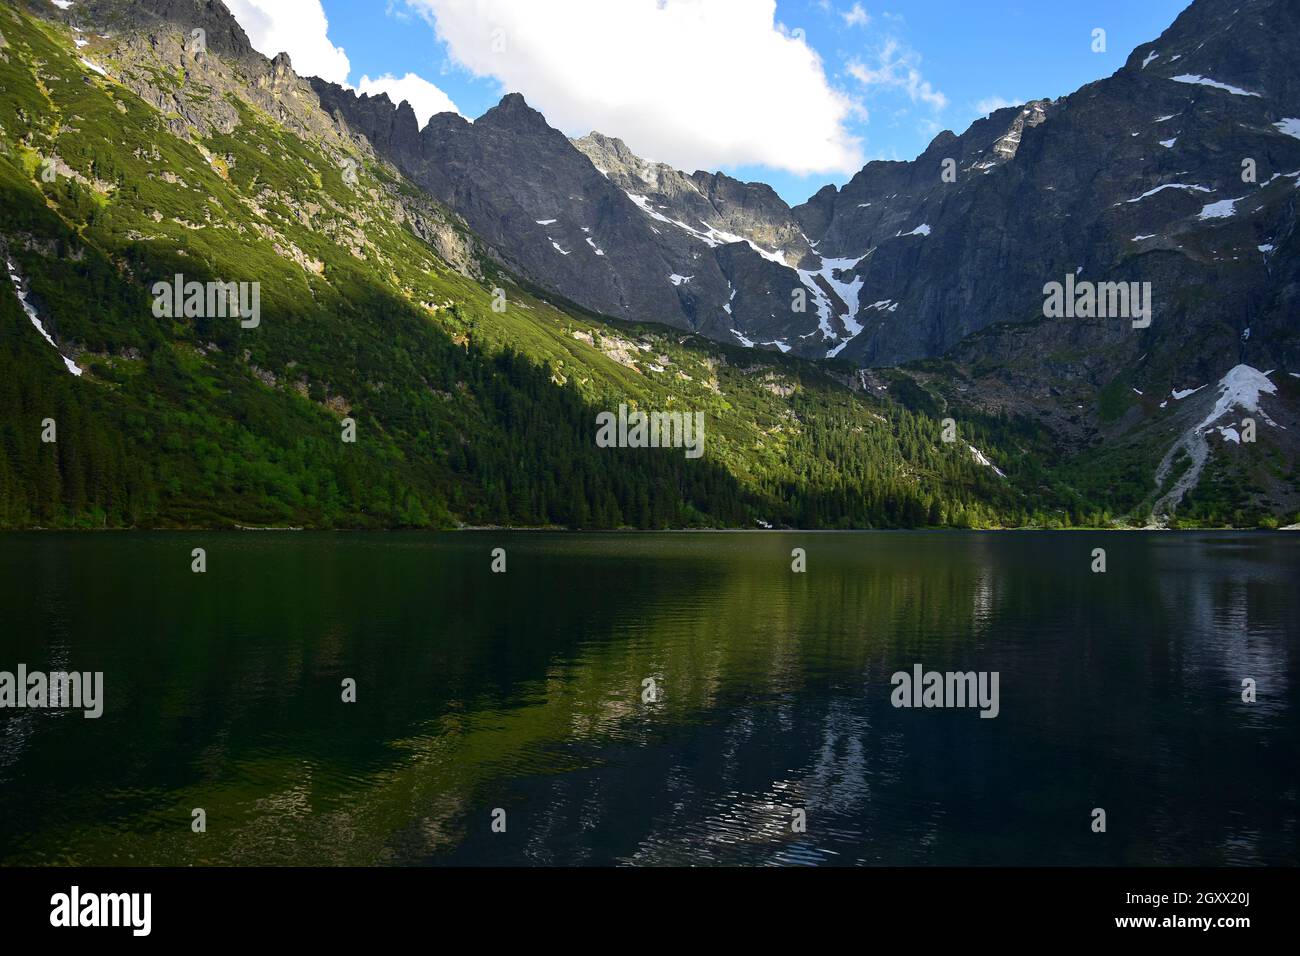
[0,0,1040,528]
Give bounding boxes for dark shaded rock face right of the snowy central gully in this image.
[794,0,1300,372]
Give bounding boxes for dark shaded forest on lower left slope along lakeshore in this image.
[0,295,755,528]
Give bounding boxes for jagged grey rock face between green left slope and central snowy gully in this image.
[312,79,832,351]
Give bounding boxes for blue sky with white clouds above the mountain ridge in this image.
[229,0,1187,203]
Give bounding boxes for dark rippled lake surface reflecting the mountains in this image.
[0,532,1300,865]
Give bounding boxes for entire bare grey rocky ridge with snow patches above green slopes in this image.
[315,0,1300,385]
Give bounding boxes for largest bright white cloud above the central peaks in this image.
[411,0,862,174]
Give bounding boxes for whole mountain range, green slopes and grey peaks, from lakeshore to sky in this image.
[0,0,1300,527]
